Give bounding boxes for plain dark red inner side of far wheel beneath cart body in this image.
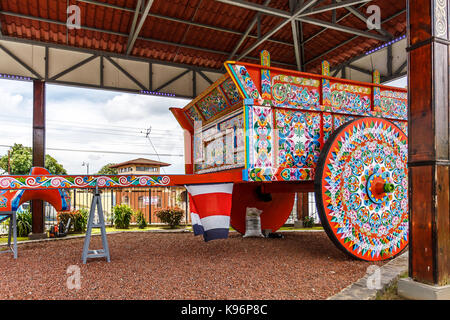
[230,183,295,234]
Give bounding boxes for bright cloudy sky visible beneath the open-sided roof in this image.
[0,77,407,174]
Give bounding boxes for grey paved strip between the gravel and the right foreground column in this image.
[327,251,408,300]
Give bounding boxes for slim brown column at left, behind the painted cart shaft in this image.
[31,80,45,238]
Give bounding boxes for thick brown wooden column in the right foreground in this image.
[408,0,450,286]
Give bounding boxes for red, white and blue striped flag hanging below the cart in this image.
[186,183,233,241]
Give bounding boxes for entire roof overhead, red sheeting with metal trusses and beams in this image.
[0,0,406,98]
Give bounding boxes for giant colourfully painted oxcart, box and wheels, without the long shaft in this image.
[171,51,408,260]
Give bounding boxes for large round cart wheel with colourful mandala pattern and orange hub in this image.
[314,117,409,261]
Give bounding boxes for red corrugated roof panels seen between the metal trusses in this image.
[0,0,406,72]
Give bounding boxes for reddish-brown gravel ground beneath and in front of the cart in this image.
[0,232,380,300]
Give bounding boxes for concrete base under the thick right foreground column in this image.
[397,278,450,300]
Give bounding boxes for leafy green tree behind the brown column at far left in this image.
[0,143,67,174]
